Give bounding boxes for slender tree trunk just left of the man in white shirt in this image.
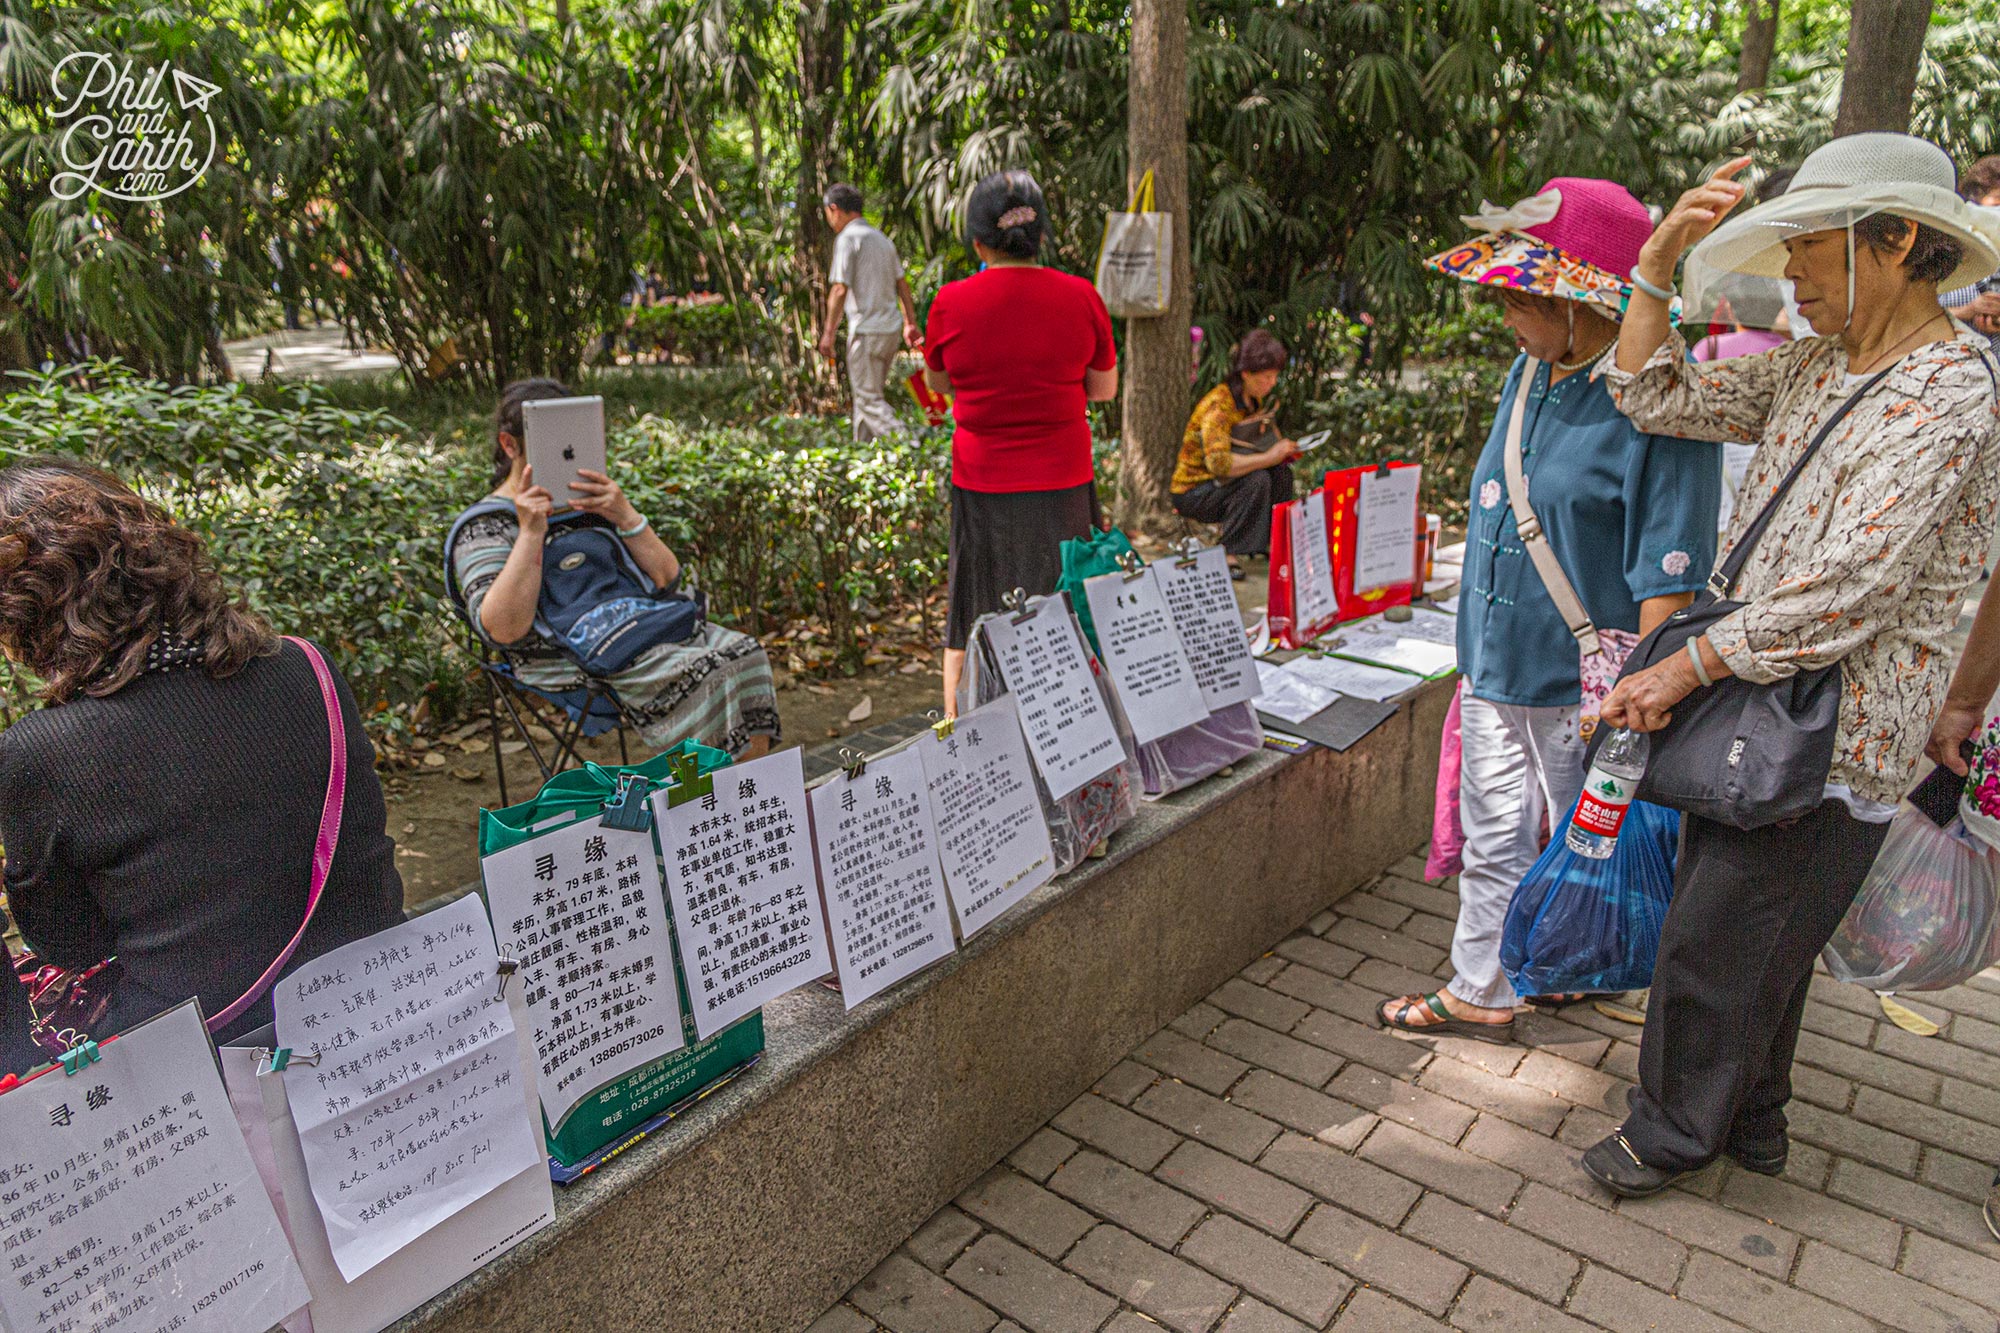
[792,0,848,406]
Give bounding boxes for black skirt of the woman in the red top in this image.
[944,482,1098,648]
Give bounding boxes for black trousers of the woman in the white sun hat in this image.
[1624,801,1888,1171]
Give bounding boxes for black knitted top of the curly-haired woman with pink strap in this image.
[0,642,402,1055]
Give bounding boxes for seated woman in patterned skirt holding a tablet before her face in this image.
[446,380,778,757]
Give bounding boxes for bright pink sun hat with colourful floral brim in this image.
[1424,176,1652,318]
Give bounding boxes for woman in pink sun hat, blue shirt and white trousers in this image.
[1376,176,1722,1041]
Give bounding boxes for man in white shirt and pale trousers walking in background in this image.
[820,184,922,440]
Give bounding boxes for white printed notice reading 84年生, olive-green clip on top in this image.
[652,749,834,1039]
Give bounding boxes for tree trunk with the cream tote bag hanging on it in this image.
[1118,0,1194,532]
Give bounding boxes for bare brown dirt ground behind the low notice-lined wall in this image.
[384,654,944,905]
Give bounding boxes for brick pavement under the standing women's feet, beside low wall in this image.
[808,859,2000,1333]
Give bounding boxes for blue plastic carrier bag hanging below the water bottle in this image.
[1500,801,1680,995]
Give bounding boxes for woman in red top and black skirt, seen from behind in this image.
[924,172,1118,717]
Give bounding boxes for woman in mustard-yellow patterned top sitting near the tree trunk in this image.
[1168,328,1298,578]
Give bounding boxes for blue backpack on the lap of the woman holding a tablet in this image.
[444,500,708,677]
